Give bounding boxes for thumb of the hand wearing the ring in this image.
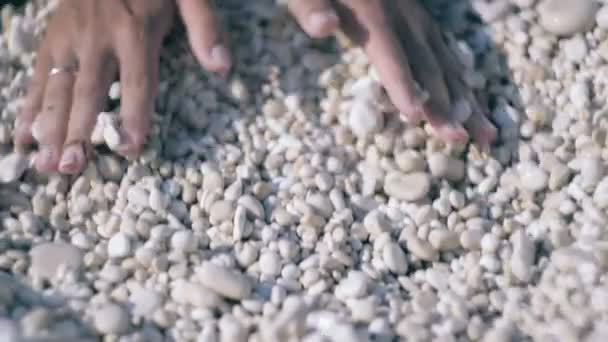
[177,0,232,74]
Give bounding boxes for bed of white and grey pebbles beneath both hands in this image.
[0,0,608,342]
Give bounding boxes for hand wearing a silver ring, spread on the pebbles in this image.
[15,0,231,174]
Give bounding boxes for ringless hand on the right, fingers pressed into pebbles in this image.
[288,0,496,148]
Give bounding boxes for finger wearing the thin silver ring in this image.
[32,59,75,173]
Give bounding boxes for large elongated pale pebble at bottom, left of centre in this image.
[196,262,252,300]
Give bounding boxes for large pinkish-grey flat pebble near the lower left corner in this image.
[30,242,82,279]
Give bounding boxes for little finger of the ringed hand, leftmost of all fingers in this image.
[15,41,51,151]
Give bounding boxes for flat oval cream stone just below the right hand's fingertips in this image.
[384,172,431,201]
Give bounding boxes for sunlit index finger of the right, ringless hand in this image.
[336,1,423,120]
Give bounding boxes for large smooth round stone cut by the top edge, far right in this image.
[538,0,596,36]
